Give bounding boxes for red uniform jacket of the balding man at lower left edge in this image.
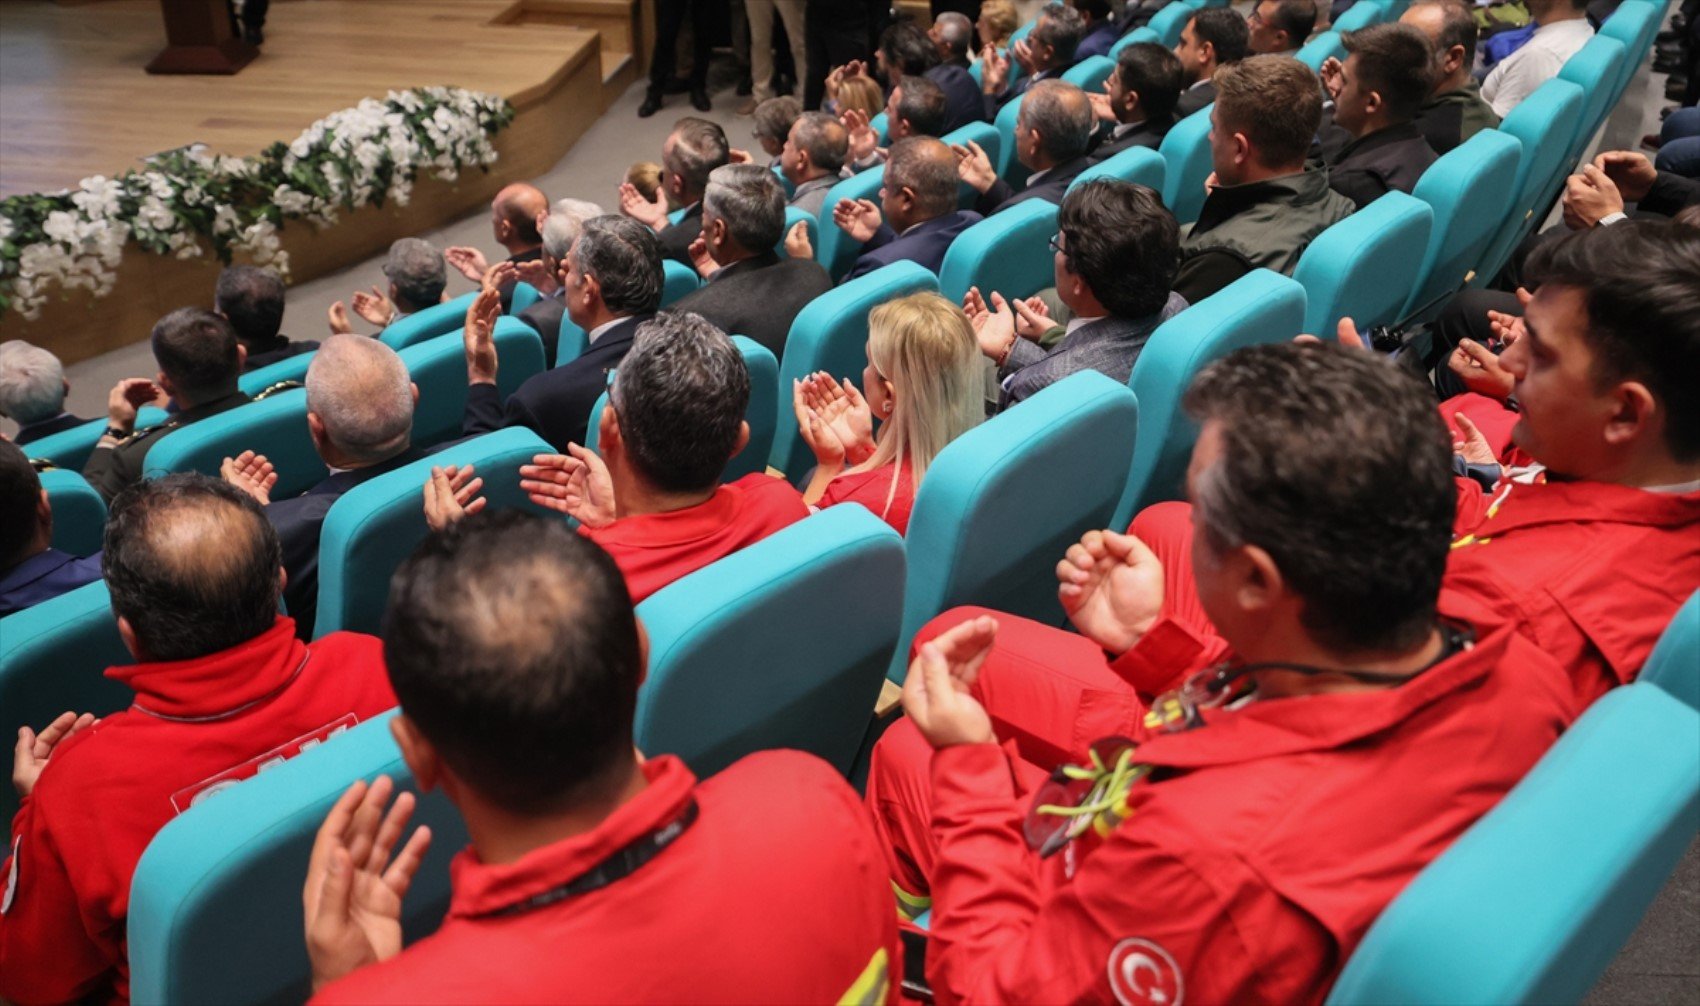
[0,617,396,1003]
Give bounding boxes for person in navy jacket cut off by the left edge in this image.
[0,440,100,617]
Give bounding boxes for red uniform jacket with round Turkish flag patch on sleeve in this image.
[927,629,1569,1004]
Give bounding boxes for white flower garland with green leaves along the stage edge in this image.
[0,87,513,321]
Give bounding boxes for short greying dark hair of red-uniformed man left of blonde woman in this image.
[609,311,750,493]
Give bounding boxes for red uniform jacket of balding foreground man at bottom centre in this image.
[315,751,903,1004]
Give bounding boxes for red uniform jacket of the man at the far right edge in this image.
[1445,483,1700,712]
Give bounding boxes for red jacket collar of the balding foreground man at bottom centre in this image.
[449,755,697,918]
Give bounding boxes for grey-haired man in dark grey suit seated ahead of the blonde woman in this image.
[675,165,833,359]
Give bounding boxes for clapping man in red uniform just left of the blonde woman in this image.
[425,311,809,603]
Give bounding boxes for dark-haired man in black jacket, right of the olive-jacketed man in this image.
[1321,24,1435,209]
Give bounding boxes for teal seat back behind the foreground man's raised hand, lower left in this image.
[128,714,468,1004]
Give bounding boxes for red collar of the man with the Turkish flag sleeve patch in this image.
[1136,627,1513,768]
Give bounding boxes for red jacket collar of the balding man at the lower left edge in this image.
[107,615,308,719]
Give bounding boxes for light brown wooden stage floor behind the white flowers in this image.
[0,0,627,195]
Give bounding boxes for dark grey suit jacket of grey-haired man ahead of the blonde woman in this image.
[673,252,833,357]
